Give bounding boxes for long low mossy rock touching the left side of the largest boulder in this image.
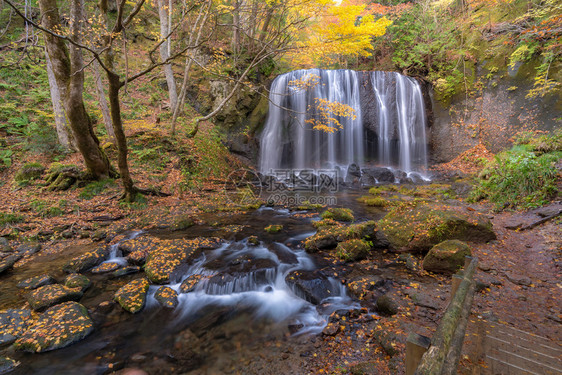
[304,221,376,252]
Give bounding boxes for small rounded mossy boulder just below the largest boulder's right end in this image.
[423,240,472,273]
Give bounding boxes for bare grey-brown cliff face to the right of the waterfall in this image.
[427,60,562,163]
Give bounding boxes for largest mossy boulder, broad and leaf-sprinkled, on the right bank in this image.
[378,204,496,251]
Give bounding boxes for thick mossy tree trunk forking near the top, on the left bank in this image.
[38,0,111,179]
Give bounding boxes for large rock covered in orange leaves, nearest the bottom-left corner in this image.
[14,302,94,353]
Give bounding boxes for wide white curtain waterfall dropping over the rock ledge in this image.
[260,69,427,174]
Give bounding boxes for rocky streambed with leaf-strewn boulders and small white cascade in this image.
[0,189,556,374]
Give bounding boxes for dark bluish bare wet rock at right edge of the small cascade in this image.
[285,270,336,305]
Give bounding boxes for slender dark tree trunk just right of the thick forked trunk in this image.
[107,72,138,202]
